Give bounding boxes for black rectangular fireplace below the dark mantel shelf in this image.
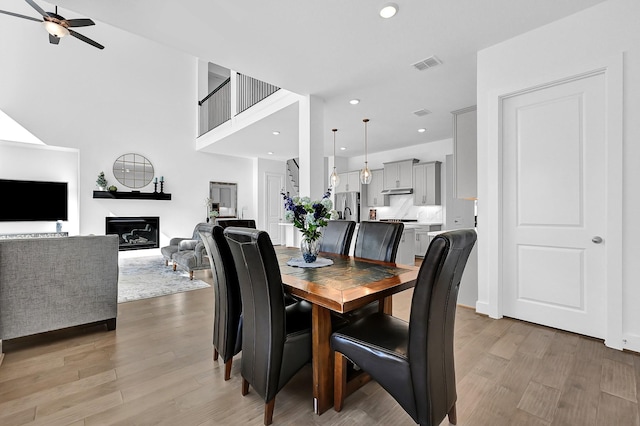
[105,217,160,251]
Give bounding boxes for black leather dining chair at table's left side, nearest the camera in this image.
[224,227,311,425]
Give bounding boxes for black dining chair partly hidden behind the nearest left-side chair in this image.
[200,225,242,380]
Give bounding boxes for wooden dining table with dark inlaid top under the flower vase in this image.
[276,246,419,414]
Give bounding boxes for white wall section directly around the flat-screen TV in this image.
[0,141,80,235]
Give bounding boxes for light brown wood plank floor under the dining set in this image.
[0,264,640,426]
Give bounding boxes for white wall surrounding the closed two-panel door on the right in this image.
[478,0,640,351]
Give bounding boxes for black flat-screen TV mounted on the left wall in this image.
[0,179,69,222]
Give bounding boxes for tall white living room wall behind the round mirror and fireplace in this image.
[0,12,255,245]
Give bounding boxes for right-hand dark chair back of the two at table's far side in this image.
[353,221,404,262]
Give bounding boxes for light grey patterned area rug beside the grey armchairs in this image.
[118,256,209,303]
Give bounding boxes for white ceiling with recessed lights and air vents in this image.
[25,0,603,158]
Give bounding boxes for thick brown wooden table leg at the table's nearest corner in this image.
[312,304,333,414]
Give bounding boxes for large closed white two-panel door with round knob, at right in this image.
[502,74,606,338]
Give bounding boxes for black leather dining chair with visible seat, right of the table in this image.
[331,229,476,426]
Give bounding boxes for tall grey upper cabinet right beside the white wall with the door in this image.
[452,105,478,199]
